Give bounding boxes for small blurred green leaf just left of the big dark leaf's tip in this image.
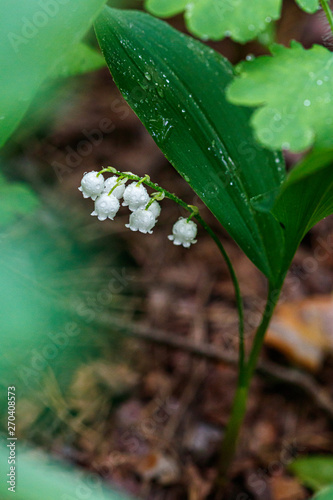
[48,43,105,78]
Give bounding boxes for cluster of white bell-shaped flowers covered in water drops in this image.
[79,171,197,248]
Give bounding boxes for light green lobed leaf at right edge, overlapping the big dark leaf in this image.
[227,42,333,152]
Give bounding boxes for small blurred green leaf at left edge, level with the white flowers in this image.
[0,174,39,227]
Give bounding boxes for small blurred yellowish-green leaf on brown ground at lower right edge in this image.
[289,455,333,490]
